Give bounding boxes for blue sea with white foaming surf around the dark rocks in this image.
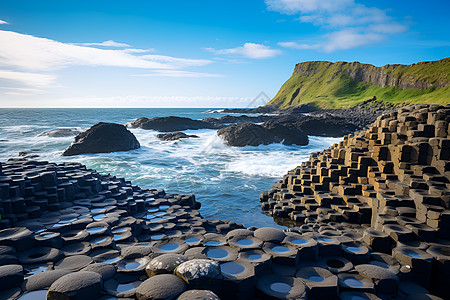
[0,108,341,228]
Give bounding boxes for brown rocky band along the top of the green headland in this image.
[294,58,450,90]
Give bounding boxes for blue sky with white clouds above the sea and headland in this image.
[0,0,450,107]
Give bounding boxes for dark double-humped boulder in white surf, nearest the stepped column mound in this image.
[217,123,308,147]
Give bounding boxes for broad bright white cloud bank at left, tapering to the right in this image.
[0,30,211,71]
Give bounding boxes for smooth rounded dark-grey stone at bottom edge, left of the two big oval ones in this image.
[47,271,103,300]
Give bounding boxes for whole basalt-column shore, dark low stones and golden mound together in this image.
[0,106,450,300]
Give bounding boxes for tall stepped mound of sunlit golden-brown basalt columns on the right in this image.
[260,105,450,298]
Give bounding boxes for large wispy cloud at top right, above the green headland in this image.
[265,0,408,52]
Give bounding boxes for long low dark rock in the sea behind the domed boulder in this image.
[127,116,220,132]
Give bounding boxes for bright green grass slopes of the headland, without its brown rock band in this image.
[268,58,450,109]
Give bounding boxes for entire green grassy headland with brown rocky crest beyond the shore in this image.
[268,58,450,109]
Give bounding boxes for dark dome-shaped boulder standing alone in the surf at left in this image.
[62,122,140,156]
